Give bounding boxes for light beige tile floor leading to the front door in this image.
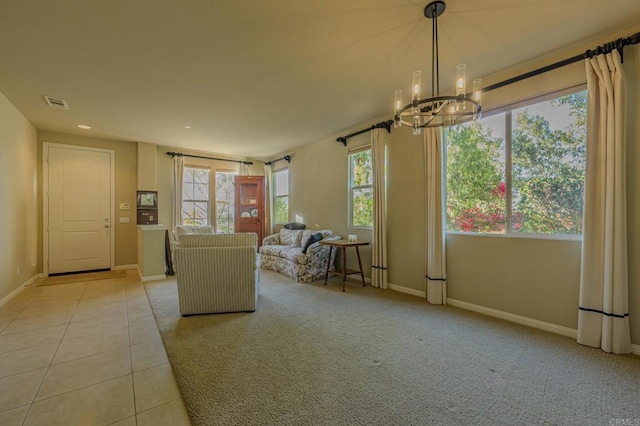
[0,270,190,426]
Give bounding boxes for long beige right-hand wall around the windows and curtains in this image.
[285,28,640,344]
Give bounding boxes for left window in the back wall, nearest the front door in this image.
[182,166,211,225]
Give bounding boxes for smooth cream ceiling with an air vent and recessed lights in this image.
[0,0,640,159]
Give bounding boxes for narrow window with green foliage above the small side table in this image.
[349,149,373,228]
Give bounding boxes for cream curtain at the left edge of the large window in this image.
[423,128,447,305]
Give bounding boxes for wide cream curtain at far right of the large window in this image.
[578,50,631,354]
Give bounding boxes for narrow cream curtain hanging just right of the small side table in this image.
[371,129,388,289]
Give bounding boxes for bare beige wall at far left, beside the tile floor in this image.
[0,93,39,300]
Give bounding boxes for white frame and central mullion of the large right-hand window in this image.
[442,83,587,241]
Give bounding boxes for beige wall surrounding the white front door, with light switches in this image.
[38,131,138,271]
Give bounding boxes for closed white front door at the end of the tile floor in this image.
[48,146,112,274]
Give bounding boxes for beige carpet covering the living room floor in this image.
[145,271,640,425]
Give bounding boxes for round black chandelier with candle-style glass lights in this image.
[394,0,482,135]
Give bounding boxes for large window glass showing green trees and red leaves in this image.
[445,91,587,235]
